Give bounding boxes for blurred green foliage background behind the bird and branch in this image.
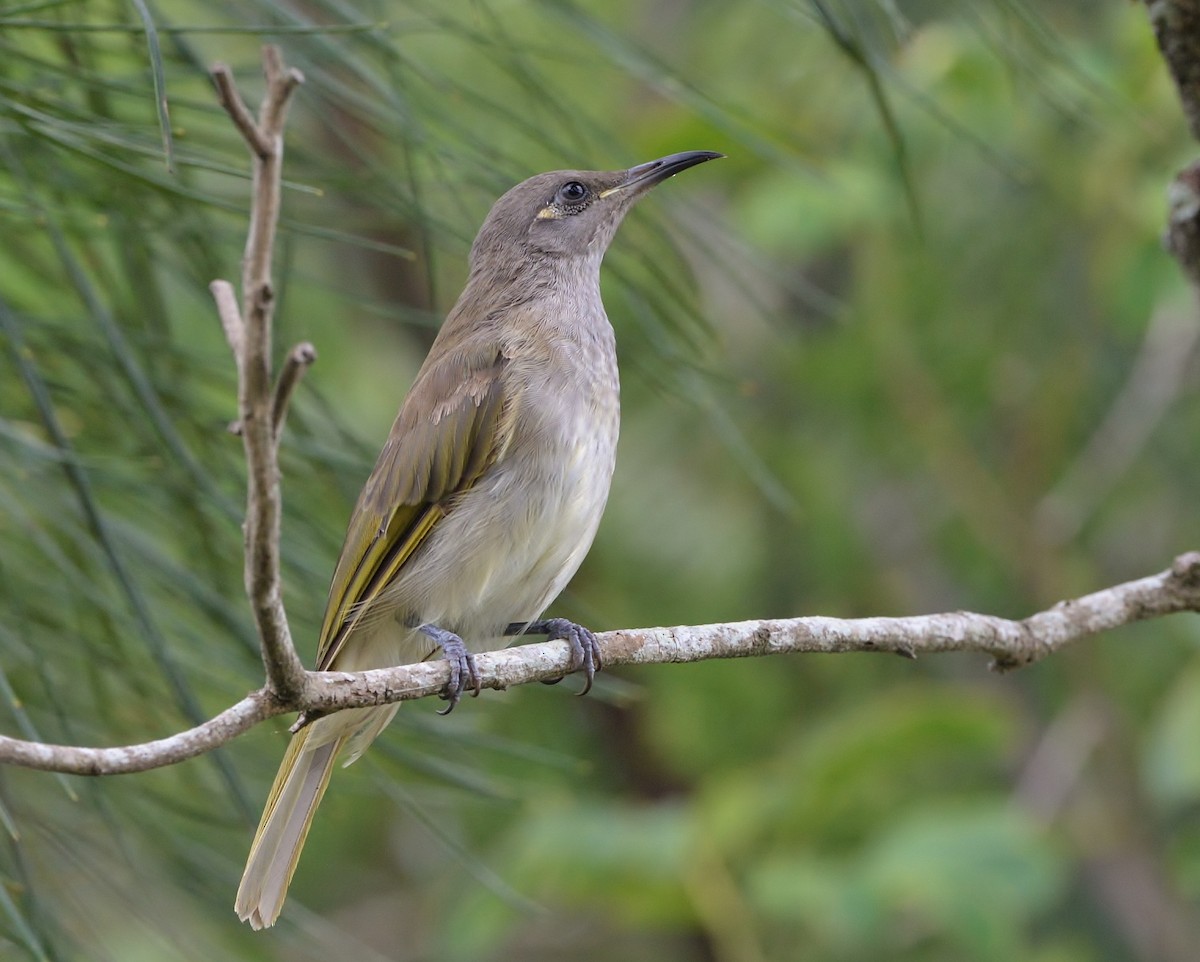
[0,0,1200,962]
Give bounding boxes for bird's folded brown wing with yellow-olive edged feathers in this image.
[317,339,514,671]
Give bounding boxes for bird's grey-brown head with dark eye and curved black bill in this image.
[472,150,724,267]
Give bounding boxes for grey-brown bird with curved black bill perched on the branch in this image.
[234,150,722,928]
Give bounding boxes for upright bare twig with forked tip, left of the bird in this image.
[212,47,305,702]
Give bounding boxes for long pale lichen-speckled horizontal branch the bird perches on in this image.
[0,552,1200,775]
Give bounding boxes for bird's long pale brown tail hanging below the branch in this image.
[234,721,347,928]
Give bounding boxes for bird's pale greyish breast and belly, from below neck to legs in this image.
[394,320,619,650]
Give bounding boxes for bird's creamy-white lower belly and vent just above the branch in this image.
[336,371,618,671]
